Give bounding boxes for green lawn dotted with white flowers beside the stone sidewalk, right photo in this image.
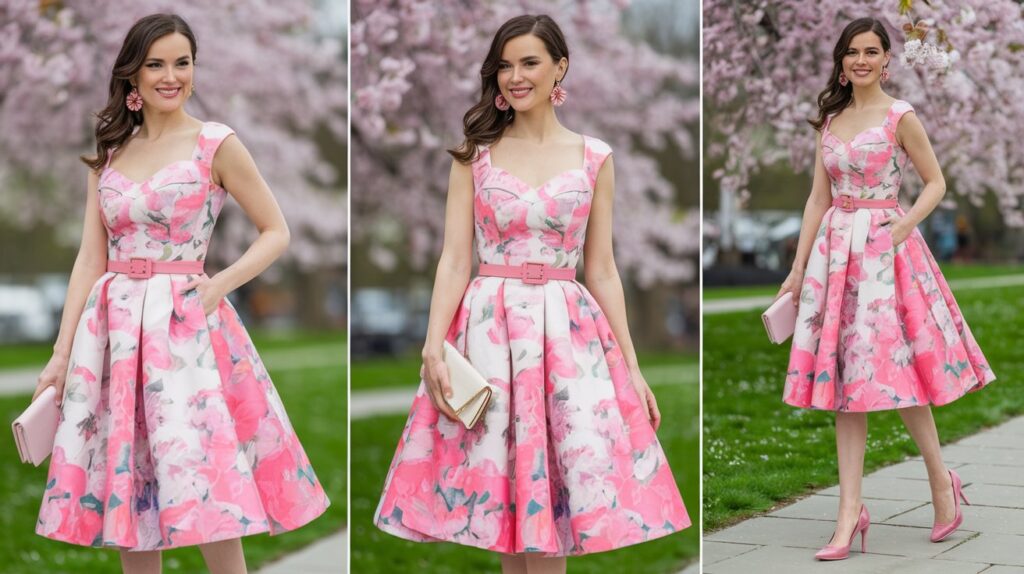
[703,284,1024,530]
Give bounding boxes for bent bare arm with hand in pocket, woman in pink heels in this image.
[892,113,946,245]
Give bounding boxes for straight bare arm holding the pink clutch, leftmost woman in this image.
[32,170,106,405]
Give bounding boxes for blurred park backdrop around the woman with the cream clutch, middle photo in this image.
[350,0,699,573]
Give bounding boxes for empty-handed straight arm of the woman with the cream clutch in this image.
[583,156,662,430]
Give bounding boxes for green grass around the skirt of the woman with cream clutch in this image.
[349,355,700,574]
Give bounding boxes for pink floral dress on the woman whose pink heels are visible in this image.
[783,100,995,412]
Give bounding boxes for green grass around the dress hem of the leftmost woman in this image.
[0,334,347,574]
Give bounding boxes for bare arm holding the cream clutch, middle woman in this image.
[421,161,473,420]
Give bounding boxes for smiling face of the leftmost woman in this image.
[135,32,196,112]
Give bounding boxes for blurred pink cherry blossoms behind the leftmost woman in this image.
[0,0,347,269]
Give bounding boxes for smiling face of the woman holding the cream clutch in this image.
[498,34,568,112]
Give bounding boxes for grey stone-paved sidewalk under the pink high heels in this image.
[703,416,1024,574]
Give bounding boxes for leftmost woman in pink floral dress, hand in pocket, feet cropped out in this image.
[33,14,329,573]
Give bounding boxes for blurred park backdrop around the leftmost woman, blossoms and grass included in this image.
[0,0,348,573]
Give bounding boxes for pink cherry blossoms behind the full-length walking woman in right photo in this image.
[703,0,1024,248]
